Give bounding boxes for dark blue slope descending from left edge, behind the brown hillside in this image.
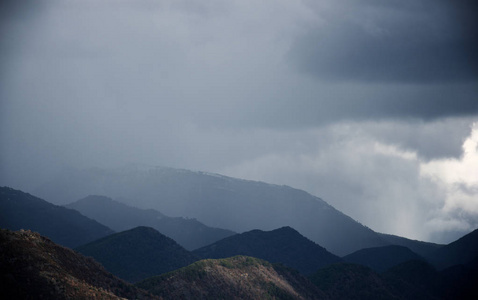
[0,187,113,248]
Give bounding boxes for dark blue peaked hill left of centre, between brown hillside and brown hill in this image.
[75,227,198,282]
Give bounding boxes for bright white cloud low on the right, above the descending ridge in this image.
[220,121,478,242]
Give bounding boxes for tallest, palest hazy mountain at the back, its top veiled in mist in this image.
[38,168,388,255]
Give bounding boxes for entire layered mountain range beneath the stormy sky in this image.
[0,168,478,299]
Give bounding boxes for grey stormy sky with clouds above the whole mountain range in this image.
[0,0,478,242]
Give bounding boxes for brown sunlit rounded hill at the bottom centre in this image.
[137,256,325,300]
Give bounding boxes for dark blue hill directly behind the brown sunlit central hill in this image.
[193,227,341,274]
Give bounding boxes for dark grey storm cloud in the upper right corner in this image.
[290,0,478,83]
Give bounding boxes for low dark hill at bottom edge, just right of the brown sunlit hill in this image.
[309,263,400,300]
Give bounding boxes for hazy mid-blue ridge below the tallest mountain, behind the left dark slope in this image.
[66,196,236,250]
